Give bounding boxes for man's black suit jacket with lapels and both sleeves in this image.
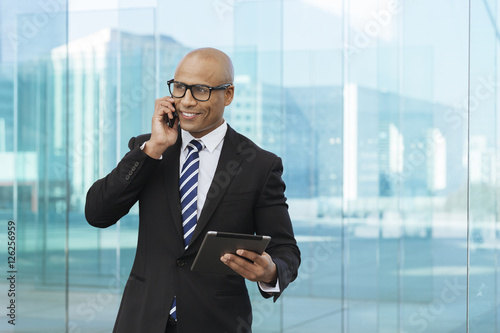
[85,127,300,333]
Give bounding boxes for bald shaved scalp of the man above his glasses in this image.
[175,47,234,85]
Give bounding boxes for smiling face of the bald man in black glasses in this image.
[174,56,234,138]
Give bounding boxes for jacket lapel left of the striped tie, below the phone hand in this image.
[162,135,184,239]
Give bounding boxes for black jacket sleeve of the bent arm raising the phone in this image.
[85,134,160,228]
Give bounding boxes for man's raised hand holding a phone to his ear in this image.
[144,96,179,159]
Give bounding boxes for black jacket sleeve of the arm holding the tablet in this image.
[254,157,300,302]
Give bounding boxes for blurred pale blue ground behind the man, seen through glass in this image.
[0,223,500,333]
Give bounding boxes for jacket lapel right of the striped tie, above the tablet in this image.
[191,125,242,248]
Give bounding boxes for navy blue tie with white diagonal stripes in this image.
[170,140,204,319]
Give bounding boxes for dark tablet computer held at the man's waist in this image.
[191,231,271,275]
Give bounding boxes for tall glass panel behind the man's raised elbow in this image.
[67,10,124,332]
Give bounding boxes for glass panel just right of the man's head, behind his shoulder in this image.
[232,1,286,332]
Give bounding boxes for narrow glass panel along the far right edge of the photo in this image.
[468,0,500,333]
